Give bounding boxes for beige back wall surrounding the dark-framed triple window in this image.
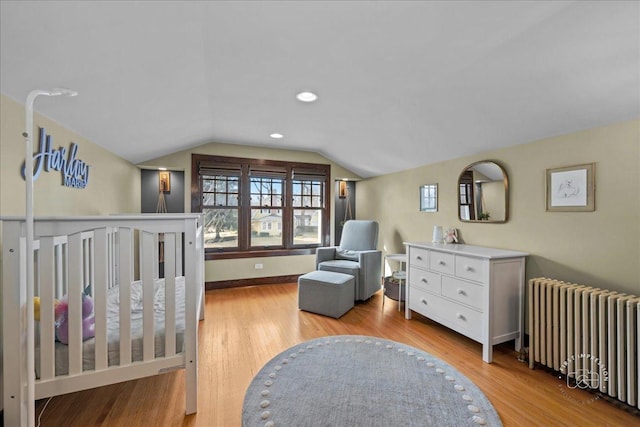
[139,143,359,282]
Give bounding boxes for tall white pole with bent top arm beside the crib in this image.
[20,89,78,426]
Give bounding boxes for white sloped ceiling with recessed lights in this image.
[0,0,640,177]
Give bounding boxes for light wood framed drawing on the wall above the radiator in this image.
[547,163,596,212]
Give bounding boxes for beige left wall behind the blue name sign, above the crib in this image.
[0,95,140,216]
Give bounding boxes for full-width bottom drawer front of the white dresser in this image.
[409,288,482,341]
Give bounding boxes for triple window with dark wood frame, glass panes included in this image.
[191,154,330,259]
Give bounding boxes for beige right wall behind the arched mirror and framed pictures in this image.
[356,120,640,295]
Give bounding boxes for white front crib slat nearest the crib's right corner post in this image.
[164,233,176,357]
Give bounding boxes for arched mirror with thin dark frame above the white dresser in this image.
[458,160,509,222]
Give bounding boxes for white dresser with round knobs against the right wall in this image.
[405,242,528,363]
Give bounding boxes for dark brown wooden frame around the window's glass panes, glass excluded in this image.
[191,154,331,260]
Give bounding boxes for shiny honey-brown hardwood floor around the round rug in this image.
[36,284,640,427]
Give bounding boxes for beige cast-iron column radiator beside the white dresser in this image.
[527,277,640,409]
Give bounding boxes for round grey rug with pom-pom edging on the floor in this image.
[242,335,502,427]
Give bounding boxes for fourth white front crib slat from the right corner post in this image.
[93,228,109,371]
